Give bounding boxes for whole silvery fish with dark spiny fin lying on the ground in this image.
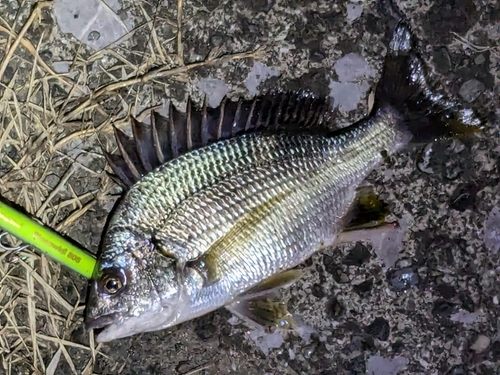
[85,20,483,342]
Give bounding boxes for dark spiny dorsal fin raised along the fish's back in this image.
[104,91,333,188]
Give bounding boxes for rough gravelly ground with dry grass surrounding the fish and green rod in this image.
[0,0,500,375]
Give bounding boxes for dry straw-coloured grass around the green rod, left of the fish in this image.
[0,0,262,375]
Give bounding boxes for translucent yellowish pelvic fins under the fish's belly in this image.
[226,269,302,329]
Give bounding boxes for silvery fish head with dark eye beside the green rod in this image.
[85,231,186,342]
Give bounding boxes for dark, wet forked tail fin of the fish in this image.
[373,21,482,142]
